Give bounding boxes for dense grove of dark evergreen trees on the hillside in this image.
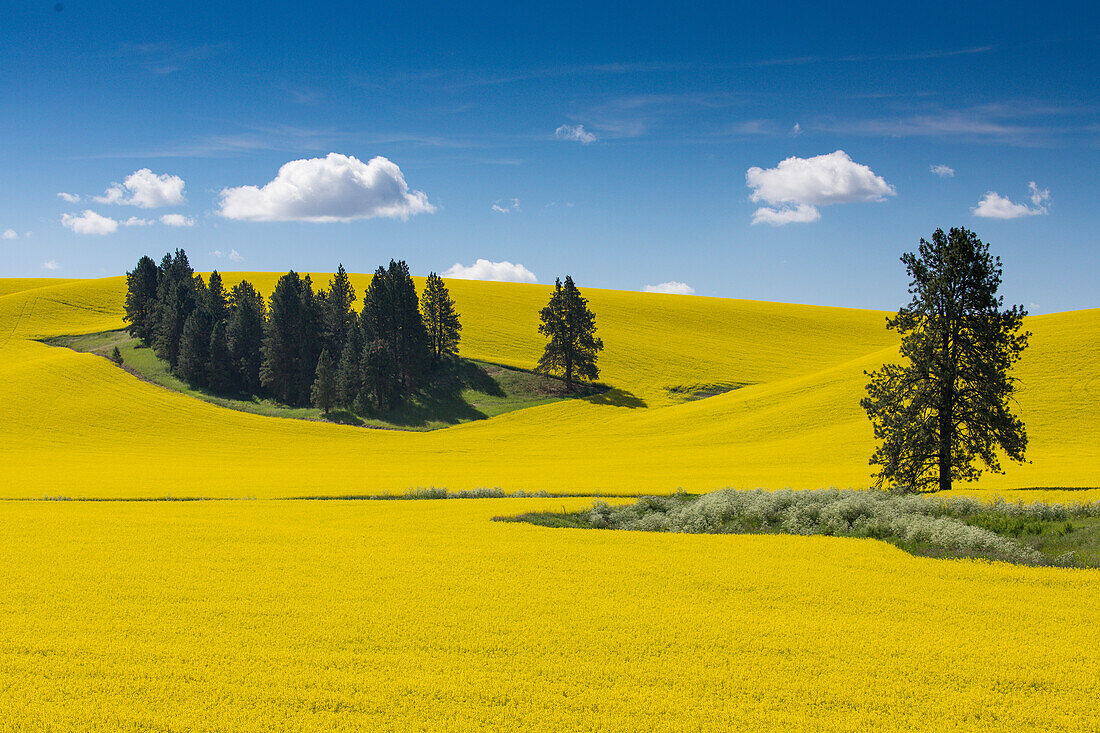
[125,250,462,413]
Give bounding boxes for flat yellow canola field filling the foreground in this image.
[0,499,1100,733]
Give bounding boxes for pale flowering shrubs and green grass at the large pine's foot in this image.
[496,489,1100,568]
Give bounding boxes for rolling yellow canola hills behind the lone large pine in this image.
[0,273,1100,501]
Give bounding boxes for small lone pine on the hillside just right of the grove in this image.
[535,275,604,392]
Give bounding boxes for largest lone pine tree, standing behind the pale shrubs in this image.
[860,228,1029,491]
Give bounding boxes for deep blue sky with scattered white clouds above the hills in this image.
[0,0,1100,313]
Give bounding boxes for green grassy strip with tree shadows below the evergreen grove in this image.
[44,330,607,430]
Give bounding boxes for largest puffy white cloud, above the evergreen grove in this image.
[218,153,436,222]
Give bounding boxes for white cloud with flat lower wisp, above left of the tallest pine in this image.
[745,150,897,226]
